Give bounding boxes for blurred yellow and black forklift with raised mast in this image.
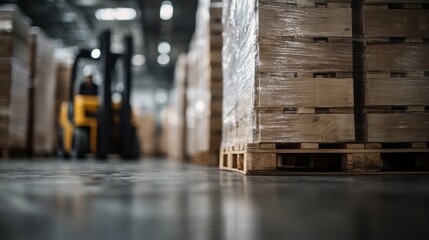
[58,30,140,159]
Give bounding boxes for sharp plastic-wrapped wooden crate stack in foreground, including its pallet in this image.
[220,0,429,174]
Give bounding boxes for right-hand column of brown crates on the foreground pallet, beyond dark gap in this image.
[355,0,429,143]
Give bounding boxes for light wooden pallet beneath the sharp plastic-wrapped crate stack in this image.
[219,142,429,174]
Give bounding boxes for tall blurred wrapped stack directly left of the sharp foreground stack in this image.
[187,0,222,166]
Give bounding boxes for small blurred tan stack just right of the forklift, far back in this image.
[137,112,157,157]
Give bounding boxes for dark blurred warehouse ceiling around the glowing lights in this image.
[0,0,197,88]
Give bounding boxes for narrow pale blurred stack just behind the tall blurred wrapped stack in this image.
[167,54,187,161]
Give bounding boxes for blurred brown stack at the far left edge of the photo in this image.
[0,6,30,158]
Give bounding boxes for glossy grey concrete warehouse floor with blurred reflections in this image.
[0,160,429,240]
